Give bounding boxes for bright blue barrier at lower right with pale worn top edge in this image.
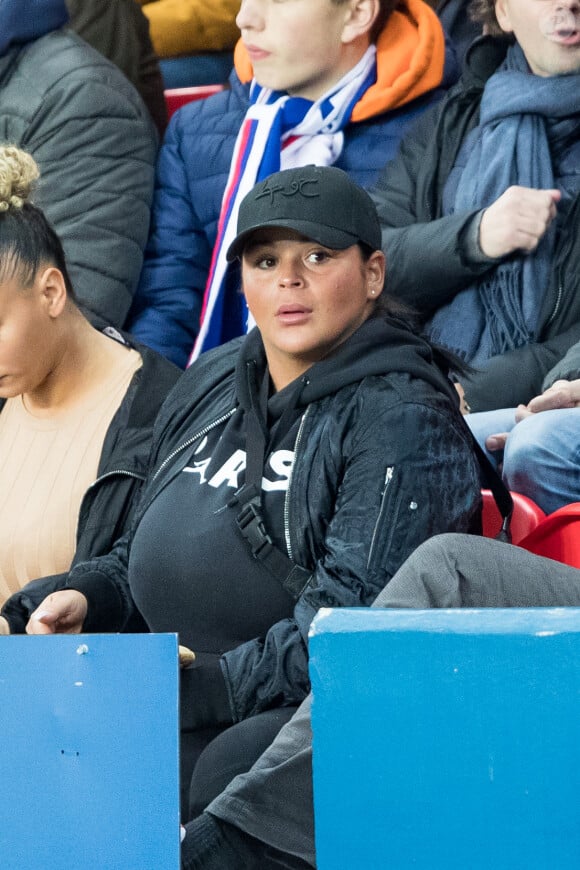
[310,608,580,870]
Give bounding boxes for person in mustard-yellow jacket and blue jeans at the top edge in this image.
[136,0,240,88]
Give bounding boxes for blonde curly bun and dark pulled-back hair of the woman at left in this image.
[0,145,75,301]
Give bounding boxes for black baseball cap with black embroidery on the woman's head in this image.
[227,166,381,261]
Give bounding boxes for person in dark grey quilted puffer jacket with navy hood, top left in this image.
[0,0,157,326]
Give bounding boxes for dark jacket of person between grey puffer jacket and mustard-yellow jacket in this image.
[66,0,167,136]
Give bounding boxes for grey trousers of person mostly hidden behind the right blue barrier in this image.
[203,534,580,867]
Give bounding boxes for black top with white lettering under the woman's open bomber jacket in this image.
[129,402,298,654]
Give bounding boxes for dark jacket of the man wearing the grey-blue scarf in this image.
[373,37,580,411]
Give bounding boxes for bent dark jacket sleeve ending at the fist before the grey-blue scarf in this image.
[371,107,491,317]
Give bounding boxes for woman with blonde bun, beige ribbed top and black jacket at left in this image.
[0,145,179,604]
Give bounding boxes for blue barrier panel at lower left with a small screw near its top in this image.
[0,634,179,870]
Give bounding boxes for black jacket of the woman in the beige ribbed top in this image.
[0,330,181,633]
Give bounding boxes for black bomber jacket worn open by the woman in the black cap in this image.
[61,318,480,724]
